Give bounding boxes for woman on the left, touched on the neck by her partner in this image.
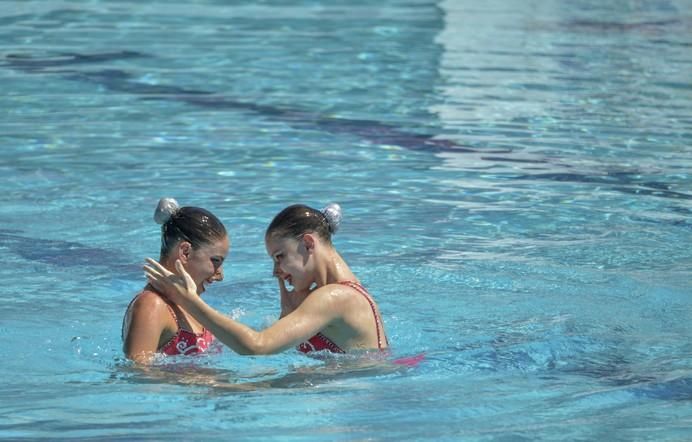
[122,198,229,364]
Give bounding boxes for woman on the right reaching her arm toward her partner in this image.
[144,204,388,354]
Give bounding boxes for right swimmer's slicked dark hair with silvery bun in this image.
[265,203,341,244]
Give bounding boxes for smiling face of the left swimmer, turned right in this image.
[185,236,230,293]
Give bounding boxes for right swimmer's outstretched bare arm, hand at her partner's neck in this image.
[144,258,340,354]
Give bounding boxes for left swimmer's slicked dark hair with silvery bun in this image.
[154,198,227,258]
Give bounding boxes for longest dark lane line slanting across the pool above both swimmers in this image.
[5,50,692,200]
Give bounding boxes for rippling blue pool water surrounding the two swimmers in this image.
[0,0,692,441]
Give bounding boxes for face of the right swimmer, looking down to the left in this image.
[266,235,314,291]
